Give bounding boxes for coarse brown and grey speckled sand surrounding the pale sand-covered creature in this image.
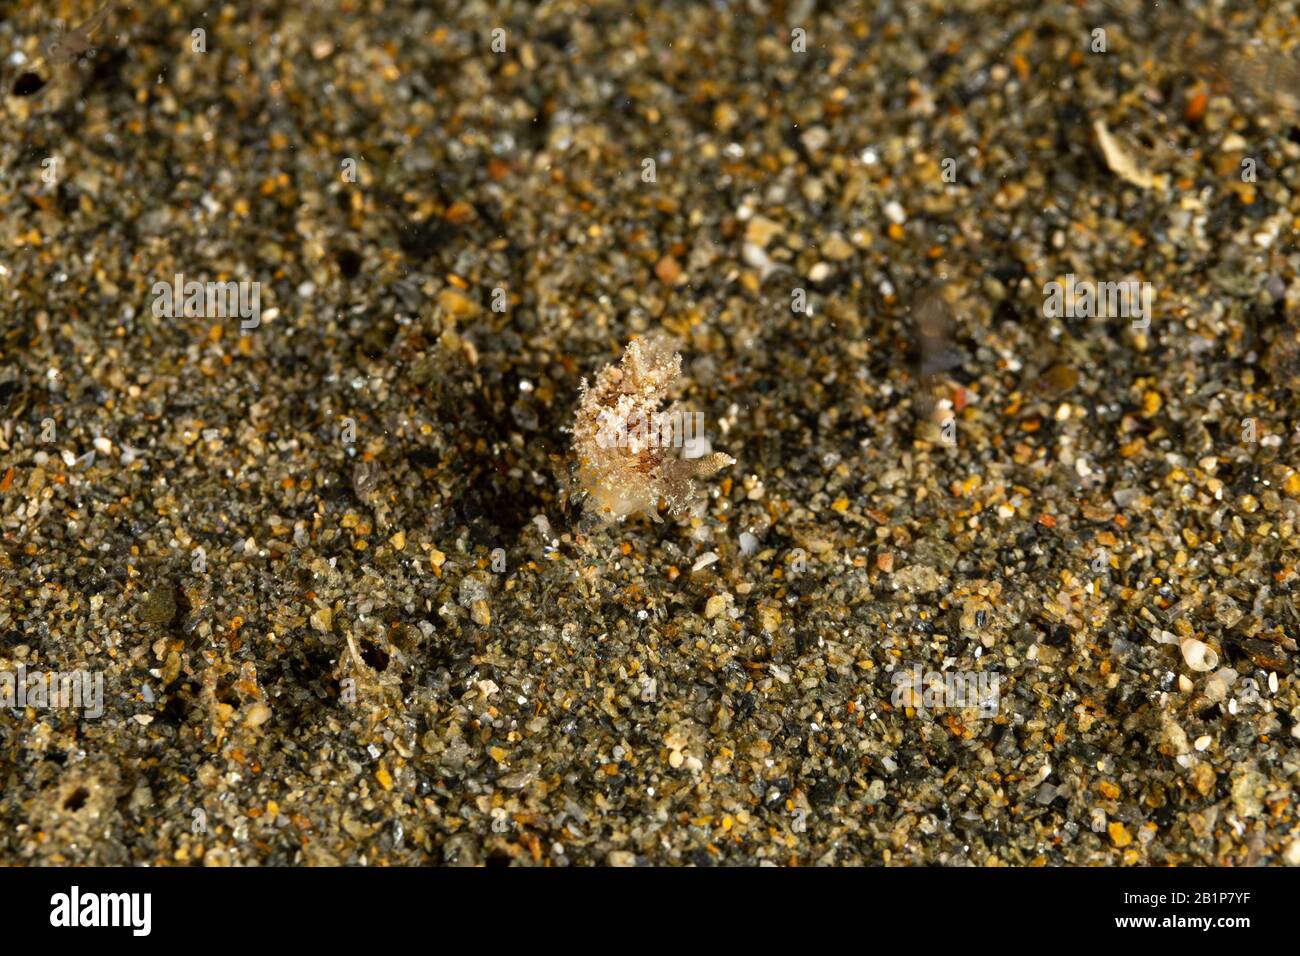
[0,0,1300,865]
